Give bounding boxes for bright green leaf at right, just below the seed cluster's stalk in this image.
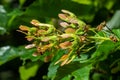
[91,40,115,61]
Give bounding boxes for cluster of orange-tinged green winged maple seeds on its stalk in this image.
[18,10,117,66]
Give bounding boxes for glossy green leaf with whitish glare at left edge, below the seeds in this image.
[0,46,39,65]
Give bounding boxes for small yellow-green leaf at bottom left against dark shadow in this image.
[19,64,39,80]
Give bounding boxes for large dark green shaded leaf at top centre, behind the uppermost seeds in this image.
[25,0,92,19]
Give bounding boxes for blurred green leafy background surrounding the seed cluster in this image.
[0,0,120,80]
